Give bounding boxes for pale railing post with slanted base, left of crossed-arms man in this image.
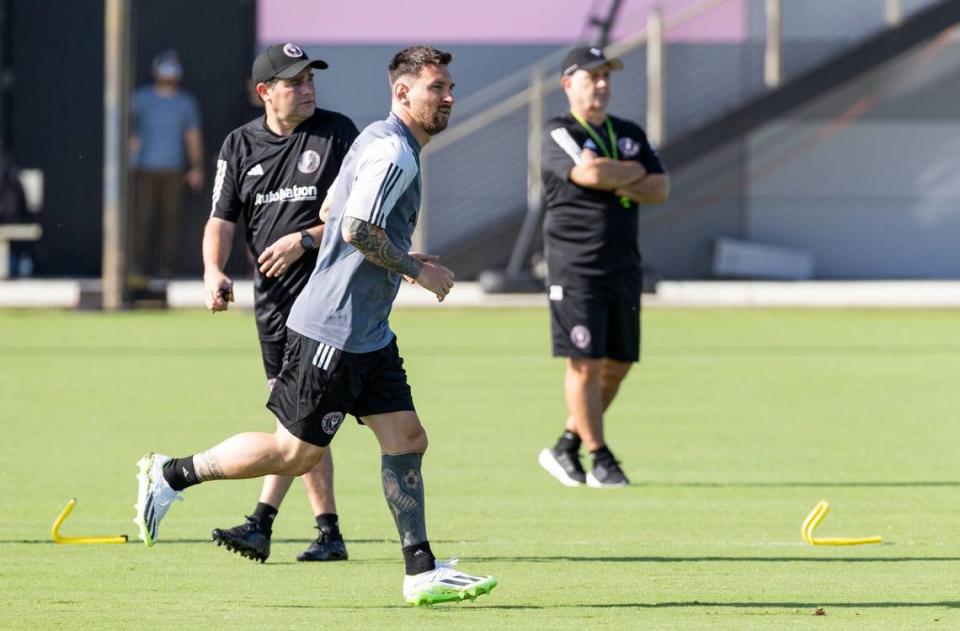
[507,65,544,278]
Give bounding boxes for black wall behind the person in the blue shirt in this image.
[3,0,256,277]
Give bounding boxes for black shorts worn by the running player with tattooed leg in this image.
[267,331,415,447]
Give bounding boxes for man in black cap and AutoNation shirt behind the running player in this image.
[203,44,358,562]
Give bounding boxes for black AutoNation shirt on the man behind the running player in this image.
[210,109,358,341]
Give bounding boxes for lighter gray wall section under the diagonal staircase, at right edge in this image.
[745,37,960,278]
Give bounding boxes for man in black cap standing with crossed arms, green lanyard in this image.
[539,47,669,488]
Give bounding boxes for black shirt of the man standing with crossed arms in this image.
[542,114,664,285]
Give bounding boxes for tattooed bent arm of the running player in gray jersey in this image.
[341,215,453,302]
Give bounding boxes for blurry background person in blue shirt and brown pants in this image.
[129,50,203,278]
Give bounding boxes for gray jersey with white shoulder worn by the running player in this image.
[287,114,420,353]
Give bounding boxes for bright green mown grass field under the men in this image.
[0,309,960,630]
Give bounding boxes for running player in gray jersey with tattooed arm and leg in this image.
[135,46,497,605]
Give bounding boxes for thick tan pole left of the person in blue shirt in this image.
[102,0,130,311]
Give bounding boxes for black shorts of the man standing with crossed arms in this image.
[549,275,641,362]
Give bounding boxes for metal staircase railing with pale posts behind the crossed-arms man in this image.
[415,0,935,260]
